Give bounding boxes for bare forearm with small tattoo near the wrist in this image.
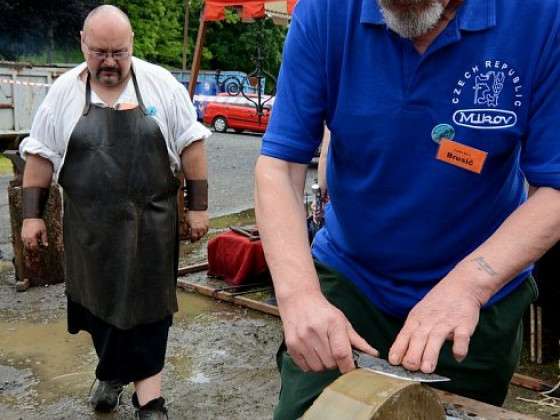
[447,188,560,304]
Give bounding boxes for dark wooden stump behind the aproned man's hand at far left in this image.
[8,182,64,286]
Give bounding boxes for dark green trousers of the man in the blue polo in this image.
[274,264,537,420]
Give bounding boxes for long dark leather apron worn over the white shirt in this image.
[59,70,179,329]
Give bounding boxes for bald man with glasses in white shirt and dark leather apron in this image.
[20,6,210,419]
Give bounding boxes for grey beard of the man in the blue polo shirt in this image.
[376,0,445,39]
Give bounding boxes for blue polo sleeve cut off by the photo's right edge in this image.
[521,18,560,189]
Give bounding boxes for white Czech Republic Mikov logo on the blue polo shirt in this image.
[451,60,524,130]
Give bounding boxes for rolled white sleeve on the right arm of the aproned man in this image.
[169,84,212,156]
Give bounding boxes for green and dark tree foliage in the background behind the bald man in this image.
[0,0,286,74]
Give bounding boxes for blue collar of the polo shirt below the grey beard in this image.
[360,0,496,31]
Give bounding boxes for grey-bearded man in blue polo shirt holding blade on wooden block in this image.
[256,0,560,419]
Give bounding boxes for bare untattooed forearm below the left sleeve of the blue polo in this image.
[255,156,320,304]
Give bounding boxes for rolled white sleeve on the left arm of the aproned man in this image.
[19,101,65,173]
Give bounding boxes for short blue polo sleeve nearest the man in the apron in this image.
[261,1,326,163]
